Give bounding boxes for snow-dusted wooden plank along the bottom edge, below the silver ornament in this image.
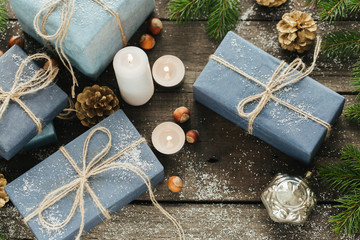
[0,204,359,240]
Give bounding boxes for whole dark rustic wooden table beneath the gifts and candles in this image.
[0,0,360,239]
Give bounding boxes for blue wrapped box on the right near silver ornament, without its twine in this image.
[194,32,345,163]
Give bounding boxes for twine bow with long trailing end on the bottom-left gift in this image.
[24,127,185,240]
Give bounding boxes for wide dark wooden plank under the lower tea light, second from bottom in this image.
[0,93,360,201]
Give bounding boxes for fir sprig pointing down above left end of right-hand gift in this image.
[206,0,241,41]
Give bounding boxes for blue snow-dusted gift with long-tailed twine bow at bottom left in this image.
[5,110,182,240]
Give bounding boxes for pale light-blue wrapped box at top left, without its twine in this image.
[10,0,155,78]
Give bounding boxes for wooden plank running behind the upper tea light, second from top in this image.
[0,21,360,93]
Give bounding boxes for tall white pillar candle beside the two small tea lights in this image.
[113,47,154,106]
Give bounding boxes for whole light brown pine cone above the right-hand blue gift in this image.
[276,11,317,53]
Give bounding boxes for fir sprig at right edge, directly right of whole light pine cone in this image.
[322,30,360,58]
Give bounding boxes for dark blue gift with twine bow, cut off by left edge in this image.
[0,45,68,160]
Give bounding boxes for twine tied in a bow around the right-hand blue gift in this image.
[210,38,331,137]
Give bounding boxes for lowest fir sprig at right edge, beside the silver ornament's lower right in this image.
[329,191,360,235]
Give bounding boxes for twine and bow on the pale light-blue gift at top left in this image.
[33,0,127,98]
